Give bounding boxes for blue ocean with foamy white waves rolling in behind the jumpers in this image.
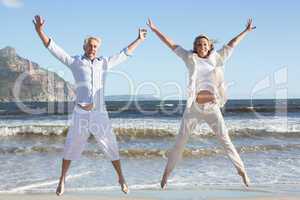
[0,99,300,193]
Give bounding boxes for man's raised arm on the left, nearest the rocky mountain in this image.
[33,15,74,67]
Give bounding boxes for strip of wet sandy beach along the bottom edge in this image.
[0,185,300,200]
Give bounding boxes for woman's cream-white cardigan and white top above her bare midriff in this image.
[174,45,233,108]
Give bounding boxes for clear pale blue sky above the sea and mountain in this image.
[0,0,300,99]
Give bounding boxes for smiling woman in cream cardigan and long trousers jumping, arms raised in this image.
[147,19,256,189]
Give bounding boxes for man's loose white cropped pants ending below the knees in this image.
[63,106,120,161]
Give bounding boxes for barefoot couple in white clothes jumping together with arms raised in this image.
[33,15,255,196]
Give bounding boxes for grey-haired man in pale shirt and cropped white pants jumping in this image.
[33,15,147,196]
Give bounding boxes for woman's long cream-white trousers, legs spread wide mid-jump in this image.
[166,102,245,174]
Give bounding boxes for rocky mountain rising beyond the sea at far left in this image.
[0,47,75,102]
